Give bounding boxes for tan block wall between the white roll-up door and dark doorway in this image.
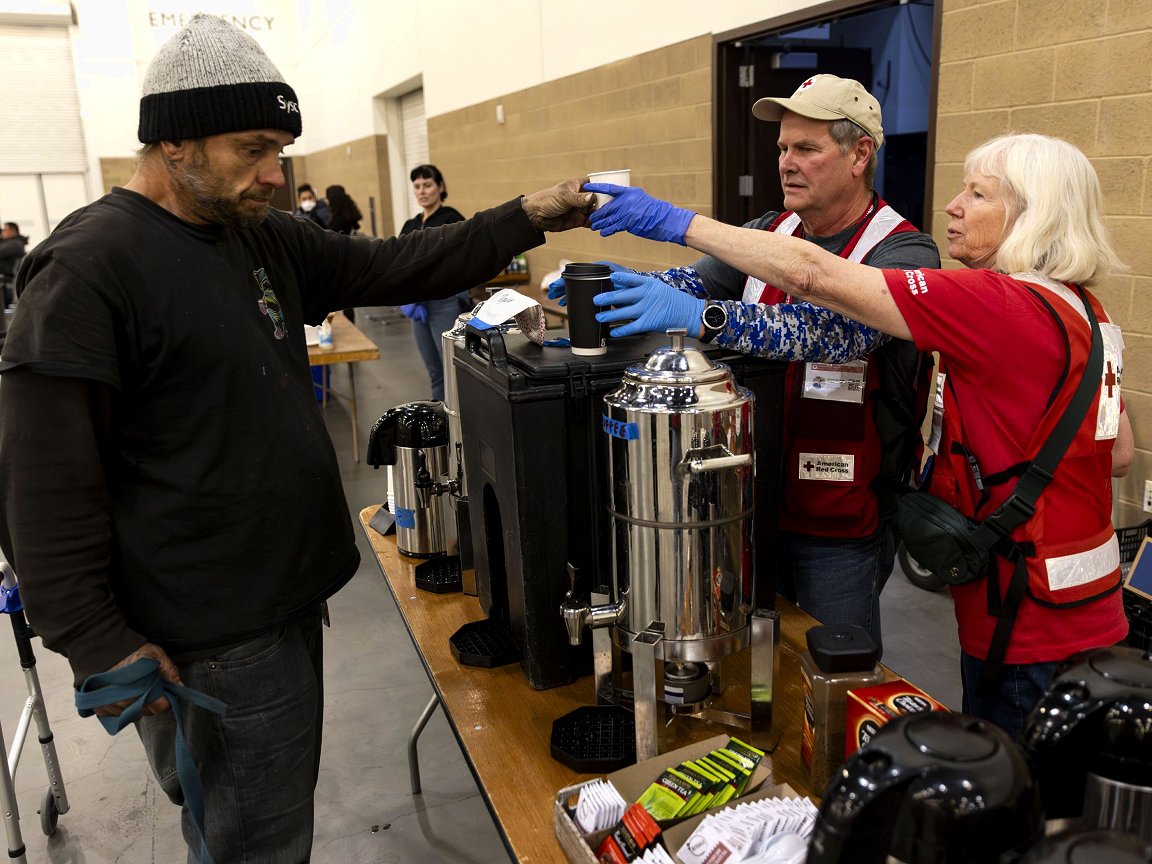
[429,36,712,282]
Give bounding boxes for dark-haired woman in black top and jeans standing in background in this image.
[400,165,471,401]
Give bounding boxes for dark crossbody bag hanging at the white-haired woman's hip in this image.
[896,492,990,585]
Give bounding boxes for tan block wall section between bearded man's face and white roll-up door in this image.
[293,135,399,237]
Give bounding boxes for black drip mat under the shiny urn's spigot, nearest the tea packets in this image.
[552,705,636,774]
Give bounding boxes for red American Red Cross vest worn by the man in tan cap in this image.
[744,205,916,538]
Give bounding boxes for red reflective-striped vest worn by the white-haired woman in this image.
[930,280,1120,606]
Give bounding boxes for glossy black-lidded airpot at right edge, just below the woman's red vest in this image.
[1020,646,1152,841]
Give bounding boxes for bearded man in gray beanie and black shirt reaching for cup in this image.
[0,8,593,863]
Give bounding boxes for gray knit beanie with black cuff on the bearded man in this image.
[139,14,301,144]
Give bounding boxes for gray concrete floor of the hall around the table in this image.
[0,309,960,864]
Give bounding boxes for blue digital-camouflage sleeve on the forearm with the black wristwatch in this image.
[715,301,892,363]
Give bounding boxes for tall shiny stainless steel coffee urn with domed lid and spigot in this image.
[561,331,775,759]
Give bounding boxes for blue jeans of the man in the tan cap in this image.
[776,522,896,653]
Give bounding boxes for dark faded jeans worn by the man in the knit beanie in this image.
[136,607,324,864]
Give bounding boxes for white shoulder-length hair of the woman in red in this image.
[964,134,1124,285]
